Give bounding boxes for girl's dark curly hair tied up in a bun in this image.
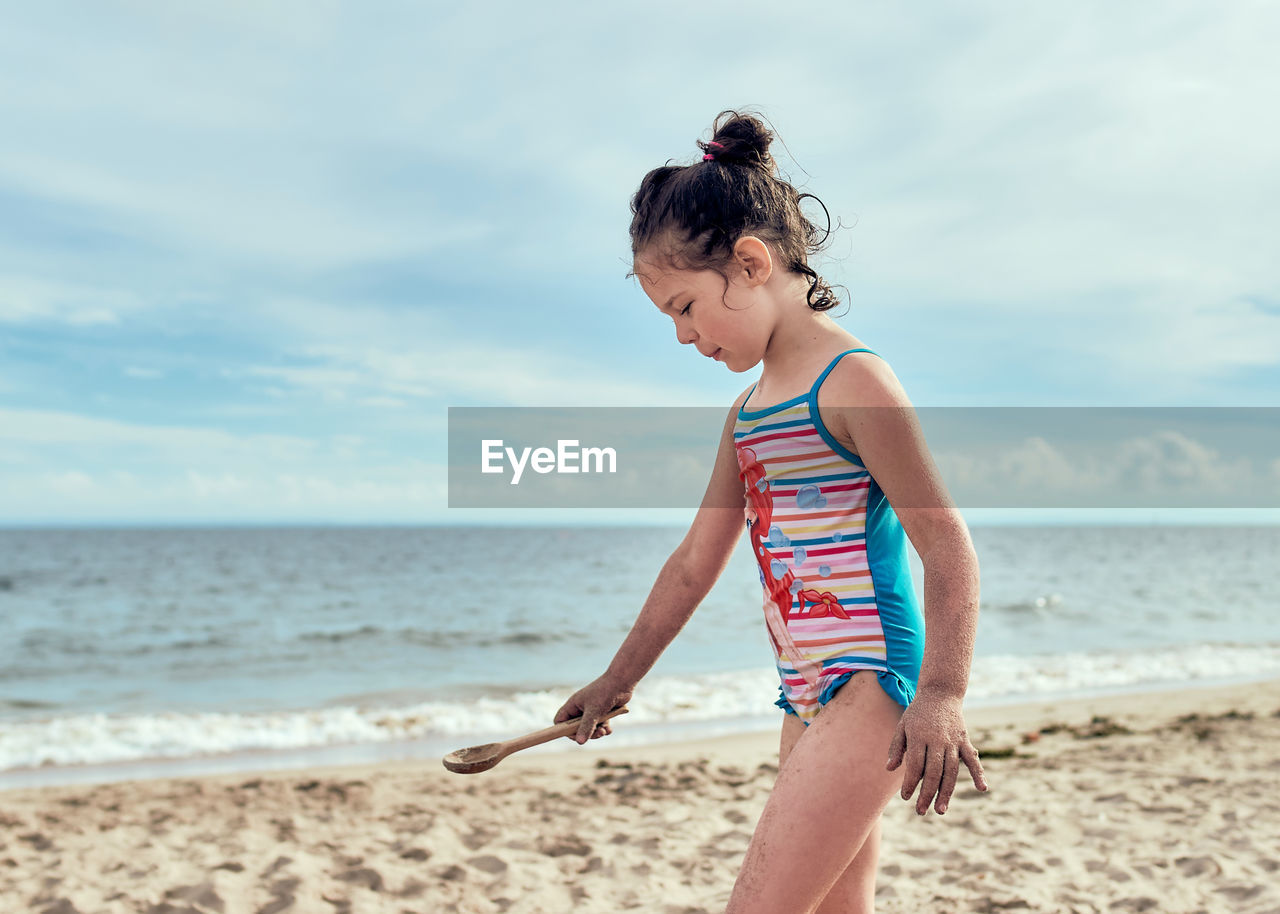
[627,110,840,311]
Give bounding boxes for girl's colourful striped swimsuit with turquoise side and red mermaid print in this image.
[733,349,924,726]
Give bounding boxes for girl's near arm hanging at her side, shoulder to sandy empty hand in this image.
[820,356,987,815]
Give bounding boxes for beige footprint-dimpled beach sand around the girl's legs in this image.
[0,681,1280,914]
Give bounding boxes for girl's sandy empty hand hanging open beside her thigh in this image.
[884,689,987,815]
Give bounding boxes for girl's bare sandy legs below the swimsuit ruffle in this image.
[726,671,902,914]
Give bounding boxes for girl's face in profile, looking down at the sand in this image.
[635,247,773,371]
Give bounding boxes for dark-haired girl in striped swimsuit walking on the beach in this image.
[556,111,987,914]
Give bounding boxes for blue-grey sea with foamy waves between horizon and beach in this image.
[0,525,1280,789]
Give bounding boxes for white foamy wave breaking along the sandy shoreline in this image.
[0,644,1280,771]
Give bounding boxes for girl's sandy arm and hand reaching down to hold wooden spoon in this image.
[556,390,748,742]
